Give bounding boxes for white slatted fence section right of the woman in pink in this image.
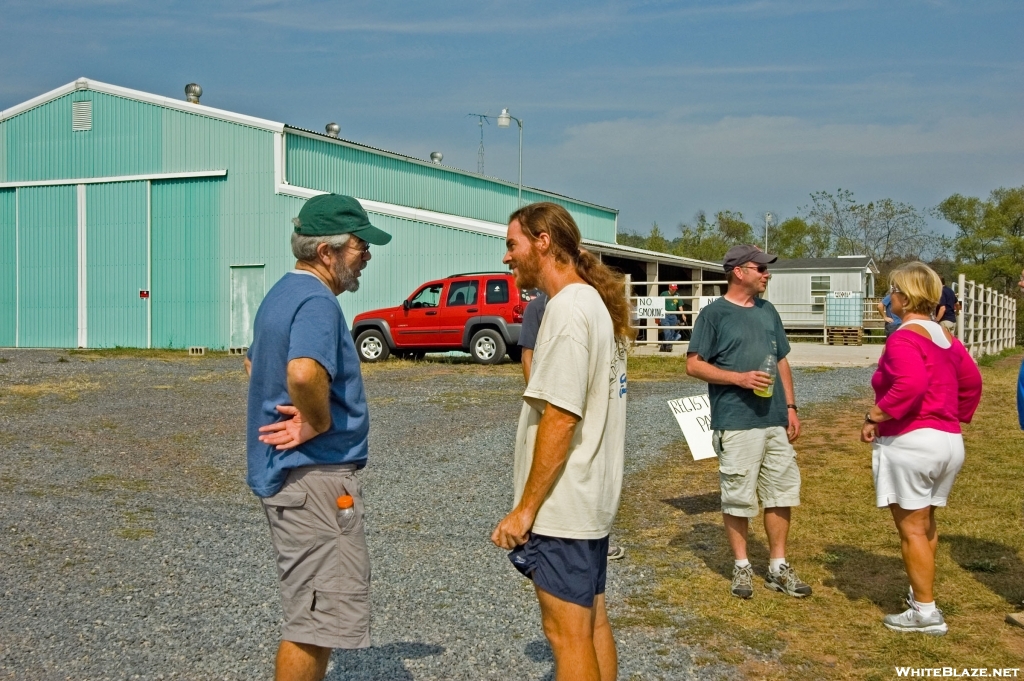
[956,274,1017,357]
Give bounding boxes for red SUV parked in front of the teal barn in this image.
[352,271,526,365]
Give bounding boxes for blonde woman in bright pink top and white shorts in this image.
[860,262,981,636]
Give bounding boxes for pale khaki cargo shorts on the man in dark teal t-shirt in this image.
[712,426,800,518]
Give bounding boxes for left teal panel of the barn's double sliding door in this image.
[17,185,78,347]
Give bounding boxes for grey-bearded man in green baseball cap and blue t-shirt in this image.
[246,194,391,681]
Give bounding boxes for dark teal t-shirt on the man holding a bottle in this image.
[686,297,790,430]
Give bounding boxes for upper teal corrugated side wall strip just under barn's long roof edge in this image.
[286,134,615,243]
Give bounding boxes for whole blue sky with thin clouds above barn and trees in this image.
[0,0,1024,236]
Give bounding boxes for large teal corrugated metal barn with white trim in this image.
[0,78,720,348]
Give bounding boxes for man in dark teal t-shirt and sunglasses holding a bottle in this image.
[686,246,811,598]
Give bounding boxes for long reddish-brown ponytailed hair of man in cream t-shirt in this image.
[509,201,636,343]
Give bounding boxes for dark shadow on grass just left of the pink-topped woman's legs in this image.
[821,544,906,611]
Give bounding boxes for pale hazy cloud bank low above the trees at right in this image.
[524,110,1024,229]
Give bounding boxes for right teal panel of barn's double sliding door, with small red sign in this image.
[85,182,147,347]
